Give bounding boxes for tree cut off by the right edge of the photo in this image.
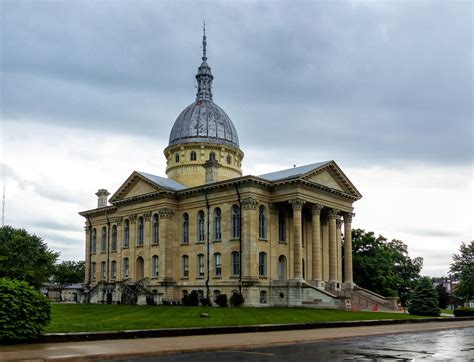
[449,240,474,301]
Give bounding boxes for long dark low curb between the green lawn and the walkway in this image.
[35,317,474,343]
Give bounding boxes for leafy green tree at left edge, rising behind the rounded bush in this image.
[0,226,59,289]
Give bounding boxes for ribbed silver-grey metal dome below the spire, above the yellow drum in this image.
[169,99,239,148]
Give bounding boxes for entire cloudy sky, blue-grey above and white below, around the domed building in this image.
[0,0,474,276]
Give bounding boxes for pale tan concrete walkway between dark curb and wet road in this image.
[0,320,474,361]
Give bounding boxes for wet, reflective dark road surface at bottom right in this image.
[121,328,474,362]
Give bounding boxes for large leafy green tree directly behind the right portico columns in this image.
[352,229,423,305]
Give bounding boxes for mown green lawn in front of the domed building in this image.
[46,304,419,333]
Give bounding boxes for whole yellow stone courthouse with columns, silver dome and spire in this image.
[80,29,396,307]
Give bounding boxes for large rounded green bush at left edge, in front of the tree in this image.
[0,278,51,343]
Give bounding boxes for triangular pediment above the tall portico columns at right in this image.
[302,161,362,199]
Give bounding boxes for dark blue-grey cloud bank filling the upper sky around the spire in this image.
[1,1,473,165]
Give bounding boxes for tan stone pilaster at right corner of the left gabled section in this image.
[158,207,176,283]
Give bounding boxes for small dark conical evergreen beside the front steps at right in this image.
[408,277,441,317]
